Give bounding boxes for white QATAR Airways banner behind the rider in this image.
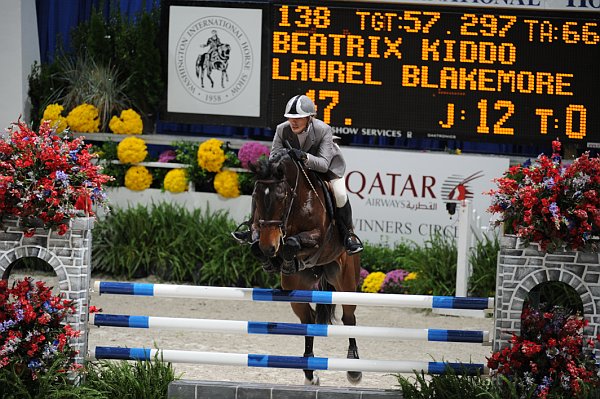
[342,147,509,245]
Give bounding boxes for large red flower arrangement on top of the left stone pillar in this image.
[0,121,111,236]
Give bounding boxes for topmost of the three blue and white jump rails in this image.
[94,281,494,310]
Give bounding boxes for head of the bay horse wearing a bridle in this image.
[250,151,298,257]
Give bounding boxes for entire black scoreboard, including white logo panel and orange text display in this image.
[161,0,600,148]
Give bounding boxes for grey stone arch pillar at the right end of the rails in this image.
[493,236,600,351]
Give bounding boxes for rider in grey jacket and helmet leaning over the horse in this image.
[233,95,363,254]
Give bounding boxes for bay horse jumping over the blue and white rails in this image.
[250,150,362,385]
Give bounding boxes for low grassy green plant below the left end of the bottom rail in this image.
[85,354,179,399]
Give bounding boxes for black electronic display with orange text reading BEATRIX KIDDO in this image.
[270,2,600,143]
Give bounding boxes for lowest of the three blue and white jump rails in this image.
[91,346,489,375]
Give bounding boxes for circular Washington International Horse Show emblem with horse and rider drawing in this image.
[175,16,254,104]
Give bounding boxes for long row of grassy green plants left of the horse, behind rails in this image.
[92,202,278,287]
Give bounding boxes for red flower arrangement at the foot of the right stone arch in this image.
[488,304,600,398]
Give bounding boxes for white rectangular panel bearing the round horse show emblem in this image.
[168,7,261,116]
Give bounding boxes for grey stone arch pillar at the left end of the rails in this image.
[0,218,95,364]
